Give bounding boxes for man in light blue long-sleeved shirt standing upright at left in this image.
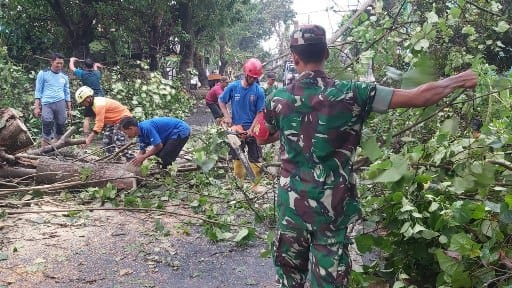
[34,53,71,147]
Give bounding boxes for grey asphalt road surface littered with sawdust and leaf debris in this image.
[0,89,277,288]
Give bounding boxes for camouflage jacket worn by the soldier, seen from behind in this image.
[264,71,376,227]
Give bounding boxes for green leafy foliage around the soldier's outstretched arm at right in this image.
[329,1,512,287]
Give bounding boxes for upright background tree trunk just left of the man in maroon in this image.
[178,1,195,87]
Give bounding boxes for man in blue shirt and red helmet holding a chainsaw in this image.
[219,58,265,179]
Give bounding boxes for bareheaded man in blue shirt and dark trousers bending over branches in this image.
[119,116,190,169]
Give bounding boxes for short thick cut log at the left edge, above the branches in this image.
[0,108,34,155]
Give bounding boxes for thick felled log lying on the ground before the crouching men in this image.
[35,157,137,189]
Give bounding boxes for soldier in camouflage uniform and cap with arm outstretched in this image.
[258,25,477,287]
